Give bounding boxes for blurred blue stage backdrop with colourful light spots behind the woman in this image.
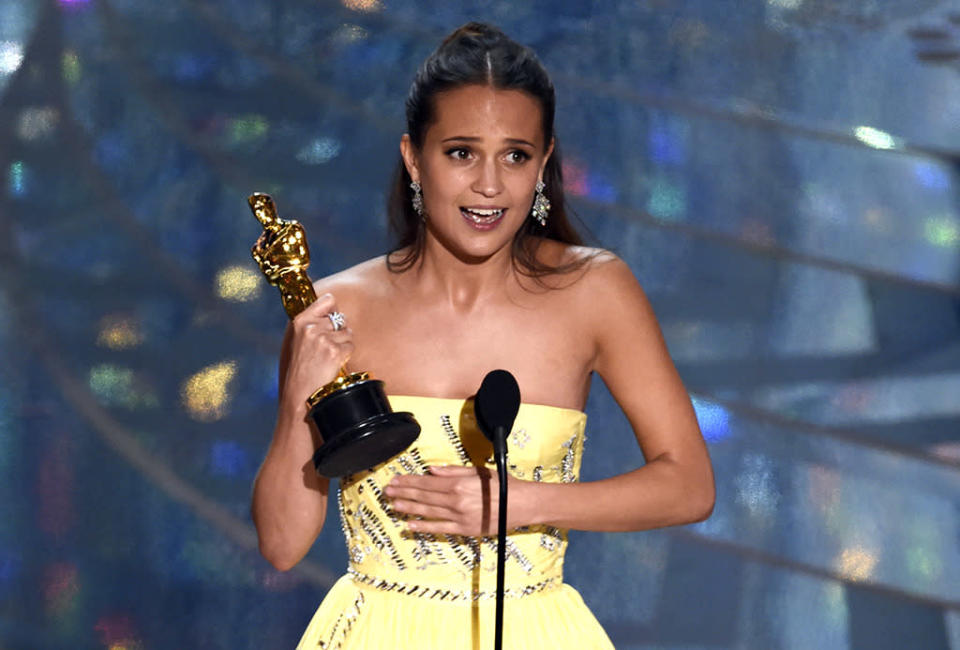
[0,0,960,650]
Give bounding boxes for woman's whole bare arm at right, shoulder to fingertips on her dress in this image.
[387,256,714,535]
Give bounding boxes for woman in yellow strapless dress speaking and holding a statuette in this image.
[253,23,714,648]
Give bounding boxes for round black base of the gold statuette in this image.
[310,379,420,478]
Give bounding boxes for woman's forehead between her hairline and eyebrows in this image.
[427,85,543,145]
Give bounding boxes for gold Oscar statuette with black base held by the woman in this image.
[247,192,420,477]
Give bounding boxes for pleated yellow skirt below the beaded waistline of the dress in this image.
[297,576,613,650]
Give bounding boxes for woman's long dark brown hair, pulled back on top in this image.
[387,22,586,278]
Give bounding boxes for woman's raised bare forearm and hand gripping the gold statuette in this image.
[251,294,353,571]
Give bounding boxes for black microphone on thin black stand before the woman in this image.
[473,370,520,650]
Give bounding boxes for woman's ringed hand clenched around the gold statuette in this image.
[282,293,353,405]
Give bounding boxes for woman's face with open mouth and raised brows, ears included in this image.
[400,85,553,262]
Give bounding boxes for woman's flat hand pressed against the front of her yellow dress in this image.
[385,465,522,536]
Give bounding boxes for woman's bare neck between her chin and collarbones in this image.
[415,234,516,311]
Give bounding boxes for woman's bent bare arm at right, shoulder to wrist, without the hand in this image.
[518,251,714,531]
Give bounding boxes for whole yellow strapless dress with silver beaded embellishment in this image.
[297,396,613,650]
